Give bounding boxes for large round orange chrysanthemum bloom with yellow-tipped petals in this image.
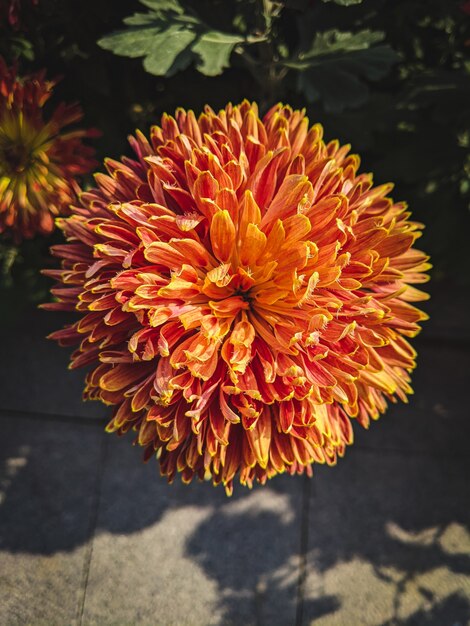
[46,102,430,493]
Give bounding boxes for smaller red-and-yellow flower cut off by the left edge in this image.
[0,58,96,241]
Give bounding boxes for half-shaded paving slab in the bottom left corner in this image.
[0,417,102,626]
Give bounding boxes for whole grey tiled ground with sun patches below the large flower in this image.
[0,288,470,626]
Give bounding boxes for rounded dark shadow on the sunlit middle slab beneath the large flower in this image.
[186,488,339,626]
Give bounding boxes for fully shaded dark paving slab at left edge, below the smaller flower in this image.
[0,308,105,418]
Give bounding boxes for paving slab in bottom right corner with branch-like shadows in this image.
[303,449,470,626]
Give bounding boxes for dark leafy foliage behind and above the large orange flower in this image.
[0,0,470,315]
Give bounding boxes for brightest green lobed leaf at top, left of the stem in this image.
[98,0,246,76]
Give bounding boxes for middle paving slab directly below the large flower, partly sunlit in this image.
[83,438,302,626]
